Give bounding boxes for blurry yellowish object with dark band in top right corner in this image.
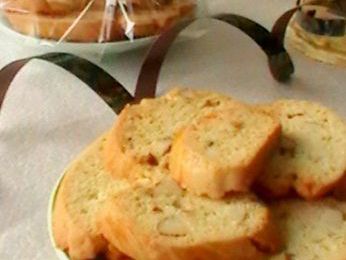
[289,0,346,66]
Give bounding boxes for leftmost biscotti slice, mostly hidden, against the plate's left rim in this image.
[52,135,127,260]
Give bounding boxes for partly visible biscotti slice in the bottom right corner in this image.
[270,199,346,260]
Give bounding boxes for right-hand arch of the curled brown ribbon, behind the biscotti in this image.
[135,14,294,101]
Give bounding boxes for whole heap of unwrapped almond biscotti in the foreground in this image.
[53,89,346,260]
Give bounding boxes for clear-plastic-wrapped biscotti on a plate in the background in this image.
[0,0,197,43]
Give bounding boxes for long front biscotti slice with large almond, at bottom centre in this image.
[100,174,280,260]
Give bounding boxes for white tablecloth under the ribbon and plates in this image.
[0,0,346,260]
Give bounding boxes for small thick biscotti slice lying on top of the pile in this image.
[169,105,281,198]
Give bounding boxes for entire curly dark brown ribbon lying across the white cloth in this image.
[0,14,294,116]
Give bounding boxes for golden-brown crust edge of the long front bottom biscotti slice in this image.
[101,197,281,260]
